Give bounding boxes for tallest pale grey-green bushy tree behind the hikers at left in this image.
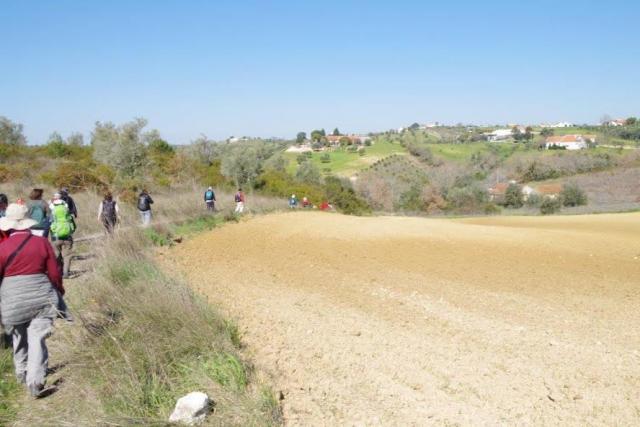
[91,118,147,178]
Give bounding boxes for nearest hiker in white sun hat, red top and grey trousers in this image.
[0,203,66,397]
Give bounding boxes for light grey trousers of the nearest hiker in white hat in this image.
[9,317,53,385]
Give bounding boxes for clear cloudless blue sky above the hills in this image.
[0,0,640,144]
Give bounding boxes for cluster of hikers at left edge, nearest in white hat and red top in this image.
[0,188,78,397]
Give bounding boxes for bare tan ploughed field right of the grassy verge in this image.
[163,212,640,425]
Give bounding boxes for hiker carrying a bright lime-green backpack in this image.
[51,193,76,279]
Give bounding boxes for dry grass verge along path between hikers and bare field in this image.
[0,189,280,425]
